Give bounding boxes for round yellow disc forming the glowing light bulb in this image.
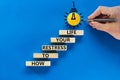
[67,12,81,26]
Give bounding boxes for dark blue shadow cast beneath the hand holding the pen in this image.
[86,25,120,54]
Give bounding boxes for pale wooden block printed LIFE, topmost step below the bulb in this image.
[59,30,84,36]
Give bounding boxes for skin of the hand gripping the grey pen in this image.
[88,6,120,40]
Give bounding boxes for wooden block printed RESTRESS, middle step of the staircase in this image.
[42,45,67,51]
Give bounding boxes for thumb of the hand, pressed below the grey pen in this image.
[90,22,107,31]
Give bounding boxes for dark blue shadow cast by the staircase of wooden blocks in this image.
[26,31,82,75]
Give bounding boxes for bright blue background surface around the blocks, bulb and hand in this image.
[0,0,120,80]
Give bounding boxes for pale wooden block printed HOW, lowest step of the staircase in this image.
[26,61,51,67]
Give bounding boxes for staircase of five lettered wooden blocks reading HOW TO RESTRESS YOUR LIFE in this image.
[26,30,84,67]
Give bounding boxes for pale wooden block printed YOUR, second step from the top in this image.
[51,37,75,43]
